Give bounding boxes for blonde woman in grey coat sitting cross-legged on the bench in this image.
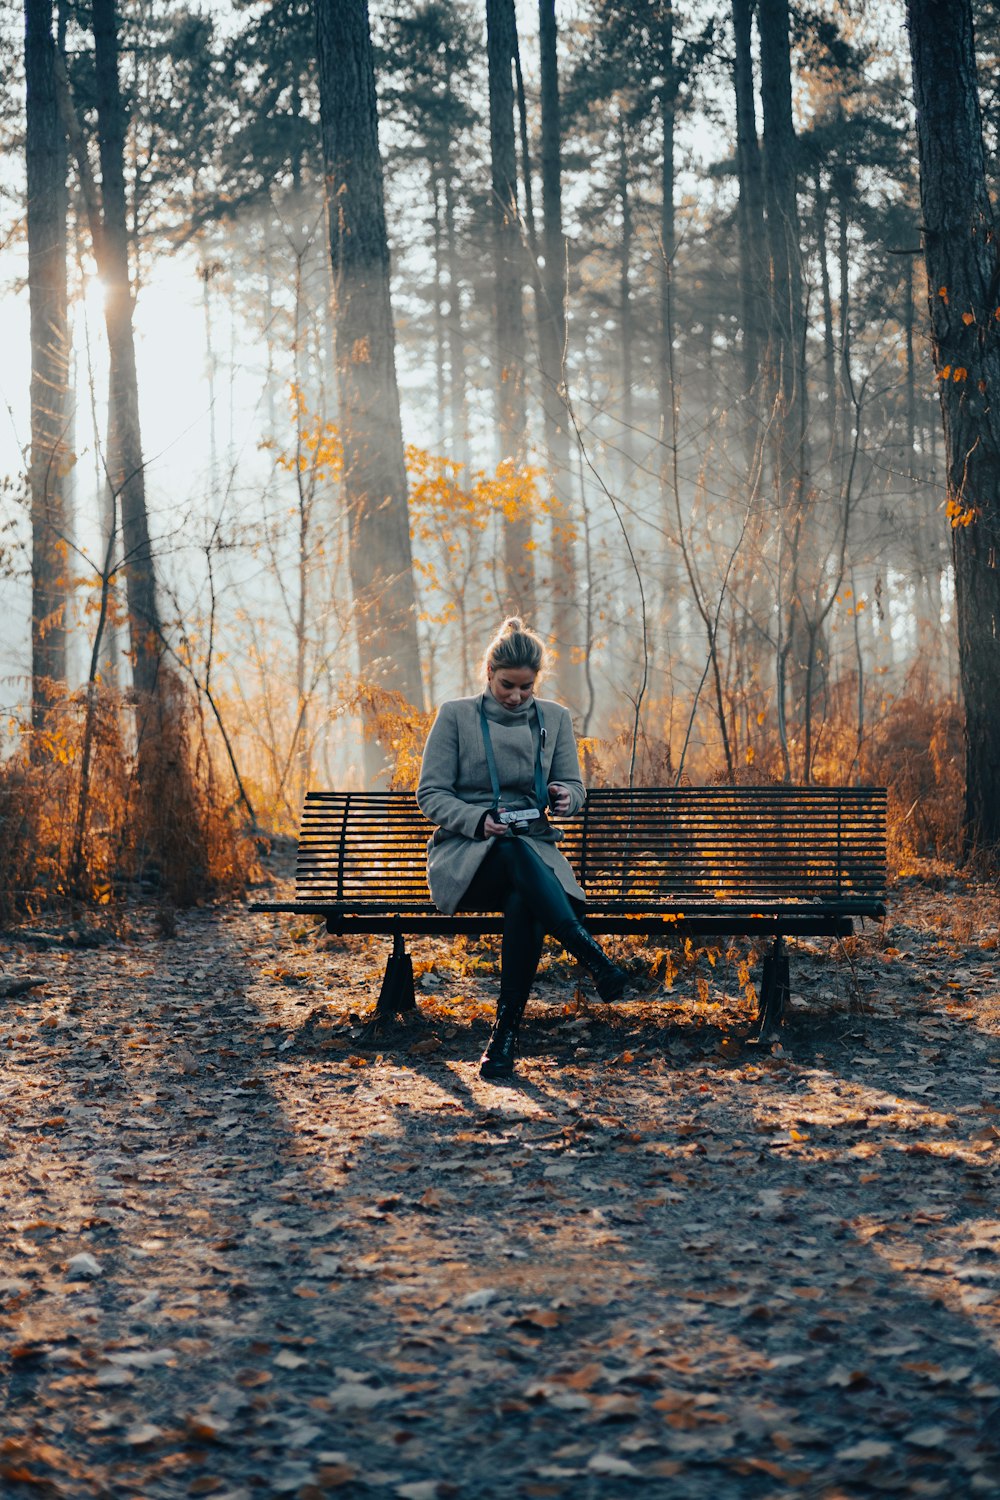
[417,617,630,1079]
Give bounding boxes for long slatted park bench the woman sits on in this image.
[253,785,886,1043]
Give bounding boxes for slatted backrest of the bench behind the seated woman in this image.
[295,786,886,906]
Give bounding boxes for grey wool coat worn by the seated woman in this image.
[417,693,586,915]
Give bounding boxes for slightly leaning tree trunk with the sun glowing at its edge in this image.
[93,0,162,695]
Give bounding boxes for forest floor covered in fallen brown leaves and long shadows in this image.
[0,858,1000,1500]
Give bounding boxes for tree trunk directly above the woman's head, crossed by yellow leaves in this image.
[486,0,535,617]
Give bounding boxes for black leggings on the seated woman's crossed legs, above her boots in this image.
[459,834,583,1007]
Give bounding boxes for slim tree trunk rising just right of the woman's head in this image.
[538,0,583,713]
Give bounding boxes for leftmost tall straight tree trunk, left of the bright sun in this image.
[24,0,72,732]
